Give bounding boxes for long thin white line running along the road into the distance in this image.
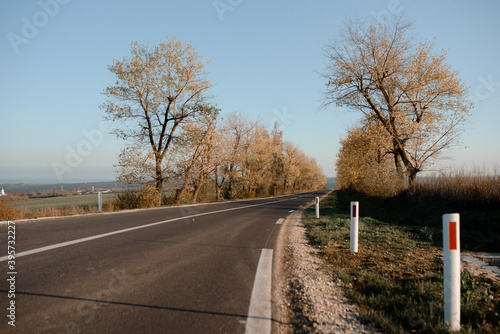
[0,199,288,262]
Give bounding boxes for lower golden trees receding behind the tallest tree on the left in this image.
[113,112,326,204]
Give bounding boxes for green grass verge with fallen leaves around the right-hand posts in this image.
[304,191,500,333]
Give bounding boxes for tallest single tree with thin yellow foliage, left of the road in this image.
[101,37,211,202]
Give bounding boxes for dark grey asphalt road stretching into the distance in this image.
[0,191,325,333]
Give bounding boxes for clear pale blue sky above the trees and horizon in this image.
[0,0,500,182]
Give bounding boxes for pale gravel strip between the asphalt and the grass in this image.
[273,211,382,334]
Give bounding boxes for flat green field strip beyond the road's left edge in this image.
[14,194,117,210]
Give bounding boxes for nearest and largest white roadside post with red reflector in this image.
[443,213,460,331]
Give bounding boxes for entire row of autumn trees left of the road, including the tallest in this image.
[102,37,326,204]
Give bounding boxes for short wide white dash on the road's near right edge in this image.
[246,248,273,334]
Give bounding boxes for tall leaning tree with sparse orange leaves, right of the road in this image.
[322,18,473,183]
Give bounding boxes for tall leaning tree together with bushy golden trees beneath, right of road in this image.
[324,17,474,196]
